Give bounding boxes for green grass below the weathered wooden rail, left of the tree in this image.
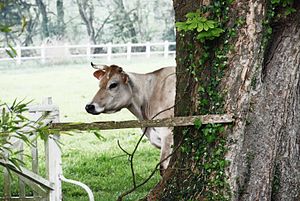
[0,129,160,201]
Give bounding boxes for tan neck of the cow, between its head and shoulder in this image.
[127,73,155,120]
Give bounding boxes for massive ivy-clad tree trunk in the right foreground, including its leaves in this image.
[148,0,300,201]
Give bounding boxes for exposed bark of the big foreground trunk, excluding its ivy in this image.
[148,0,300,201]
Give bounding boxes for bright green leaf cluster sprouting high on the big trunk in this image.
[176,10,224,43]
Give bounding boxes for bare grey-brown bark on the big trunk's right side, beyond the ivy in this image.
[224,1,300,201]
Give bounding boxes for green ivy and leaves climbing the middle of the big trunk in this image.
[164,0,239,201]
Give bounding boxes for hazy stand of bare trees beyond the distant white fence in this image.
[0,0,175,46]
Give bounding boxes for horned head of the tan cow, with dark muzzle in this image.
[85,63,132,115]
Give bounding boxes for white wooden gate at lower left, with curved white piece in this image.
[0,98,94,201]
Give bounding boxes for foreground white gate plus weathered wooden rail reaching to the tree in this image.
[0,98,234,201]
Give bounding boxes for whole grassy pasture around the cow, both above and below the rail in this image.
[0,57,175,201]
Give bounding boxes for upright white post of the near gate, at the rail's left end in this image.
[44,98,62,201]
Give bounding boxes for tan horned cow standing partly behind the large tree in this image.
[85,63,176,174]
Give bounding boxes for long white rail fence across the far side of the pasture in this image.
[0,41,175,64]
